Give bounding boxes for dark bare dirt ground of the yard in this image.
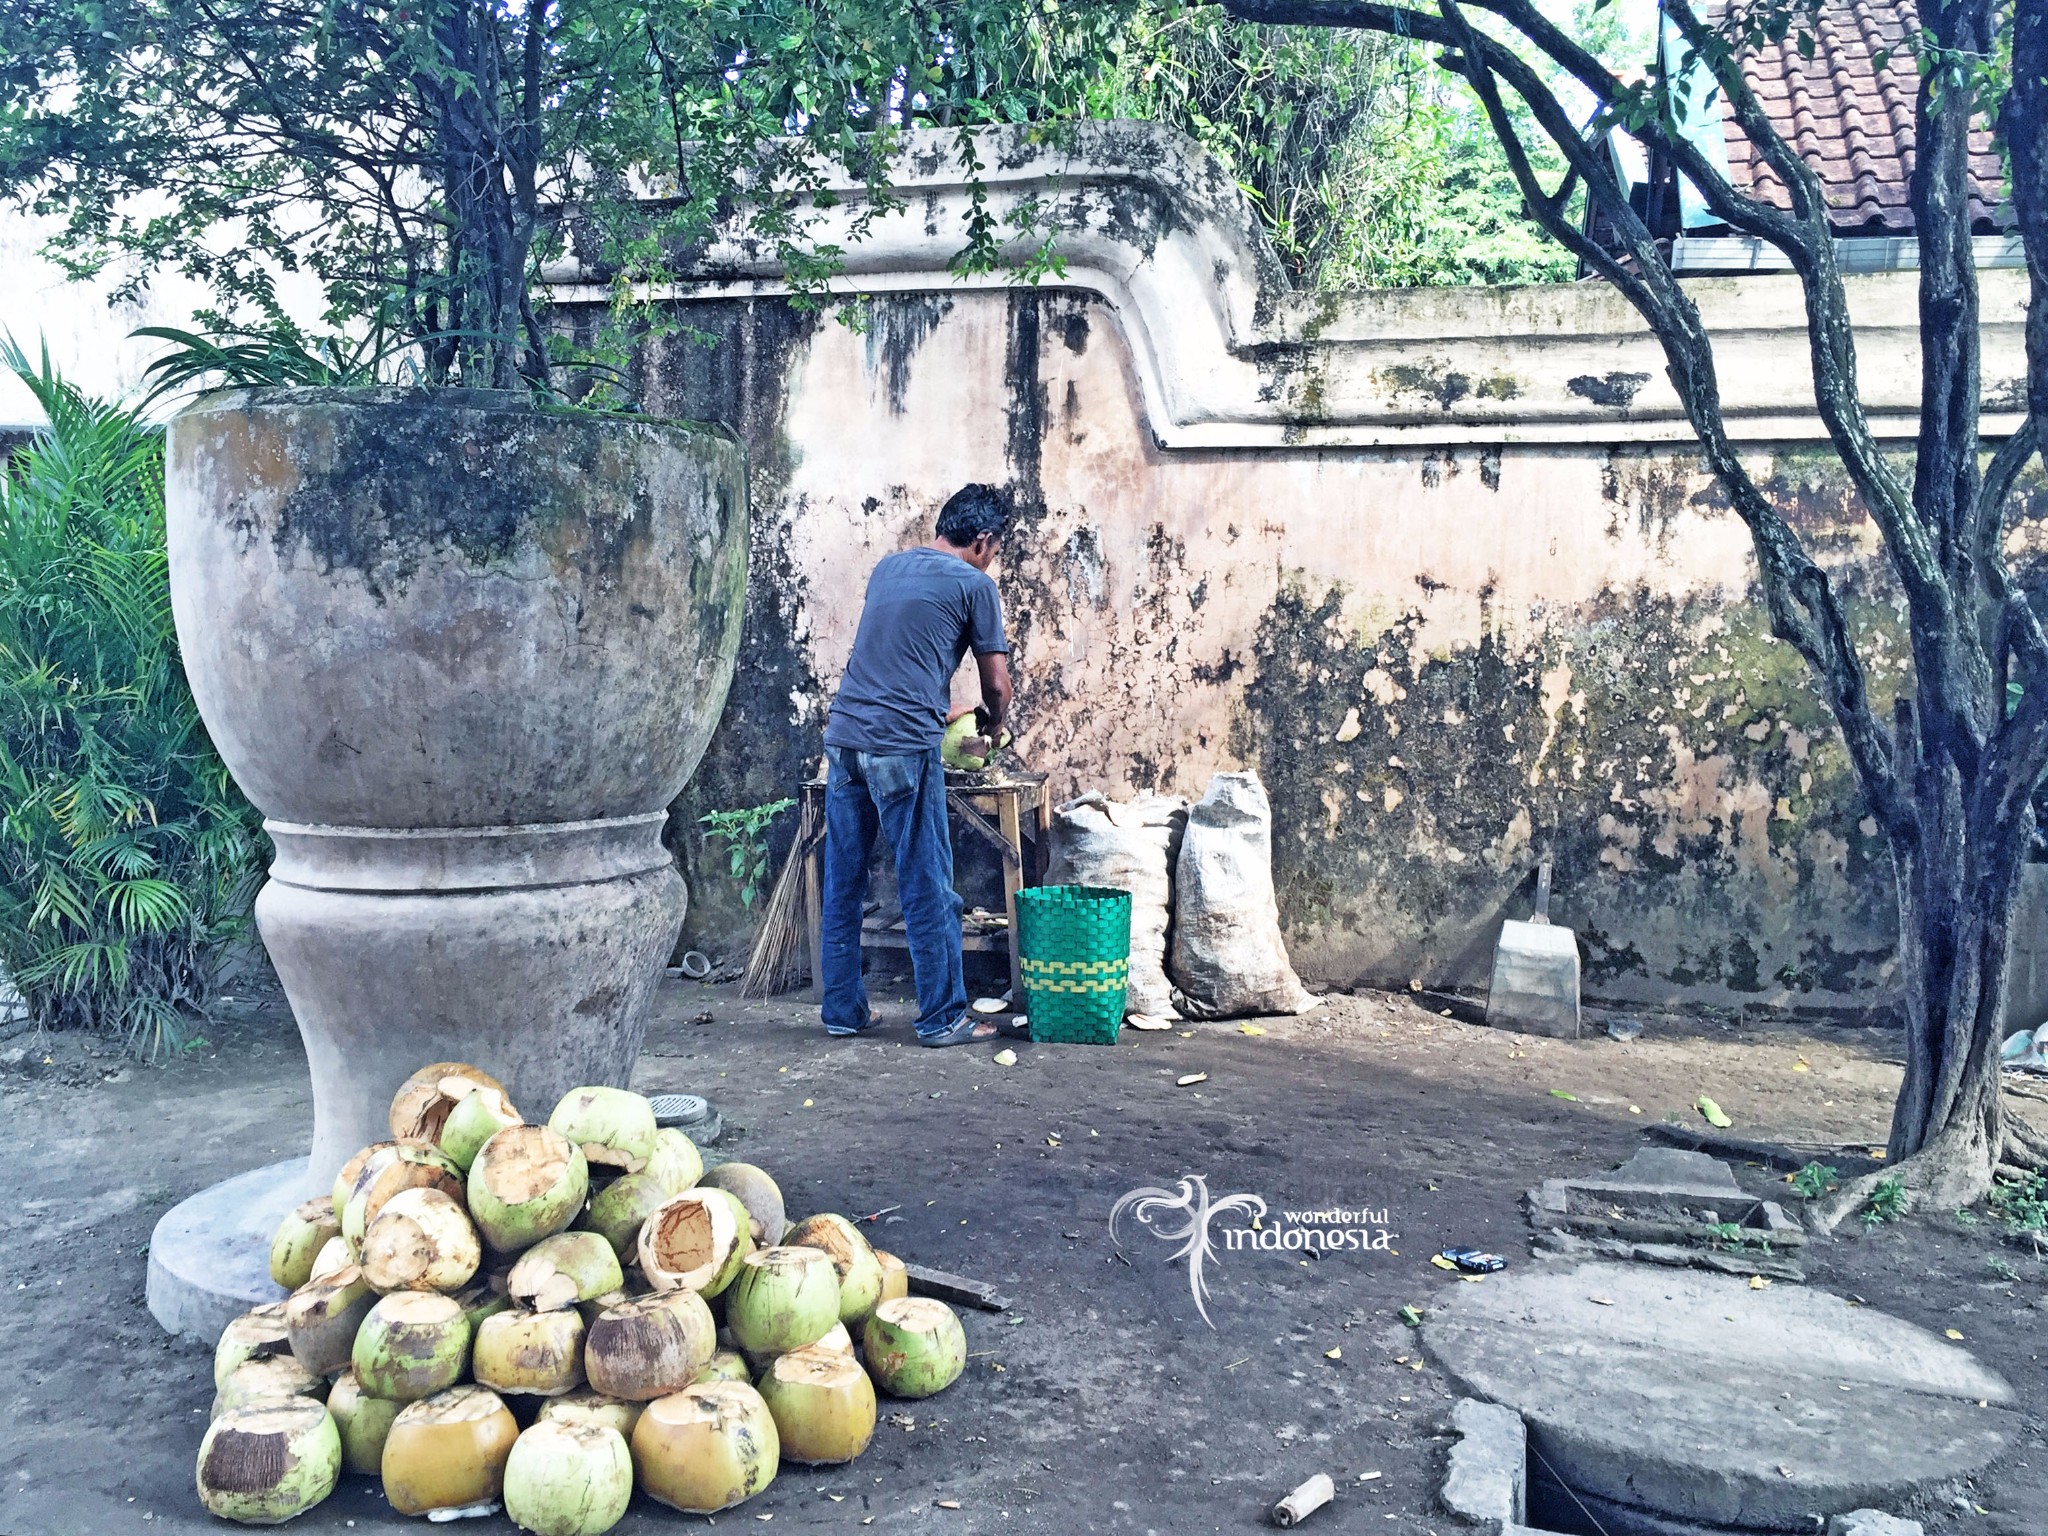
[0,981,2048,1536]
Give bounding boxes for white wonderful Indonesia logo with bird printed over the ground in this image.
[1110,1174,1399,1327]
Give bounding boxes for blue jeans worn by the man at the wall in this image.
[819,748,967,1034]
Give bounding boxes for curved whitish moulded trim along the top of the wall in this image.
[547,123,2025,449]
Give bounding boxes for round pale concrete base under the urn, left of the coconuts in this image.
[147,1157,311,1348]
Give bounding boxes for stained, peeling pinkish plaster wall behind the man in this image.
[569,120,2048,1006]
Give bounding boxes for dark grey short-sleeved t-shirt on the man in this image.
[825,549,1010,752]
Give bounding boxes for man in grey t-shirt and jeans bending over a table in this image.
[819,485,1010,1047]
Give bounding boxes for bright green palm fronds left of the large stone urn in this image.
[0,342,262,1057]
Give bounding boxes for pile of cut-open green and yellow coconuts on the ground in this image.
[199,1063,967,1536]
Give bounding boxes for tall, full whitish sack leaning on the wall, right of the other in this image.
[1171,774,1321,1018]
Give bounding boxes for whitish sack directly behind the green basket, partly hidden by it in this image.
[1047,795,1188,1018]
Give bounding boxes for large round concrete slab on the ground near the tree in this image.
[1423,1264,2021,1532]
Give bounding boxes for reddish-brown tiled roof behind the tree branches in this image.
[1722,0,2005,236]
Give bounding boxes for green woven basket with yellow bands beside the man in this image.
[1018,885,1130,1044]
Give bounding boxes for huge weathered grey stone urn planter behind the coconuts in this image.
[152,389,748,1323]
